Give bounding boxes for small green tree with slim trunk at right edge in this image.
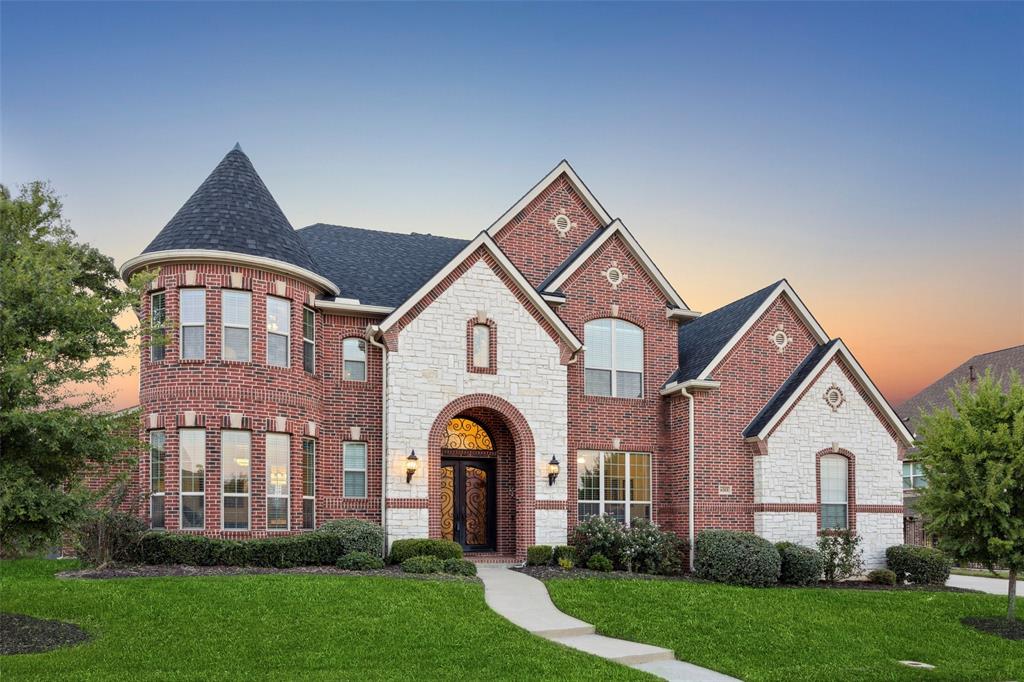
[919,371,1024,620]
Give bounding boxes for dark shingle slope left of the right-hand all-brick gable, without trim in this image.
[667,280,782,383]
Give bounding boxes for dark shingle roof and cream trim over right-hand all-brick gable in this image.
[666,280,828,387]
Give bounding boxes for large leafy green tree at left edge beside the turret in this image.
[0,182,144,554]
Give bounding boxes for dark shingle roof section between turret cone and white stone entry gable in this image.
[295,223,469,307]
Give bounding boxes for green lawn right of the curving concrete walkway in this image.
[548,580,1024,682]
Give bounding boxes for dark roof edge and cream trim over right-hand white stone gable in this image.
[743,339,913,446]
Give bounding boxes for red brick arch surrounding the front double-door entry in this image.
[426,393,537,556]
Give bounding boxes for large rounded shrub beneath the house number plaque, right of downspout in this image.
[694,530,782,587]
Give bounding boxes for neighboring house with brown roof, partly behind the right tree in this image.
[899,345,1024,545]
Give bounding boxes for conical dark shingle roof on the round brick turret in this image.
[142,145,321,272]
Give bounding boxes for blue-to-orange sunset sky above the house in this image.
[0,1,1024,407]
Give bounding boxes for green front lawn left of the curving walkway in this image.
[0,560,651,682]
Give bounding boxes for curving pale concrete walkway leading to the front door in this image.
[476,564,737,682]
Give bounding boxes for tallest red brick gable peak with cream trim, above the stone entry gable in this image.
[487,162,611,288]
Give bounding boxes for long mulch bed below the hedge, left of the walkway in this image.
[56,565,479,582]
